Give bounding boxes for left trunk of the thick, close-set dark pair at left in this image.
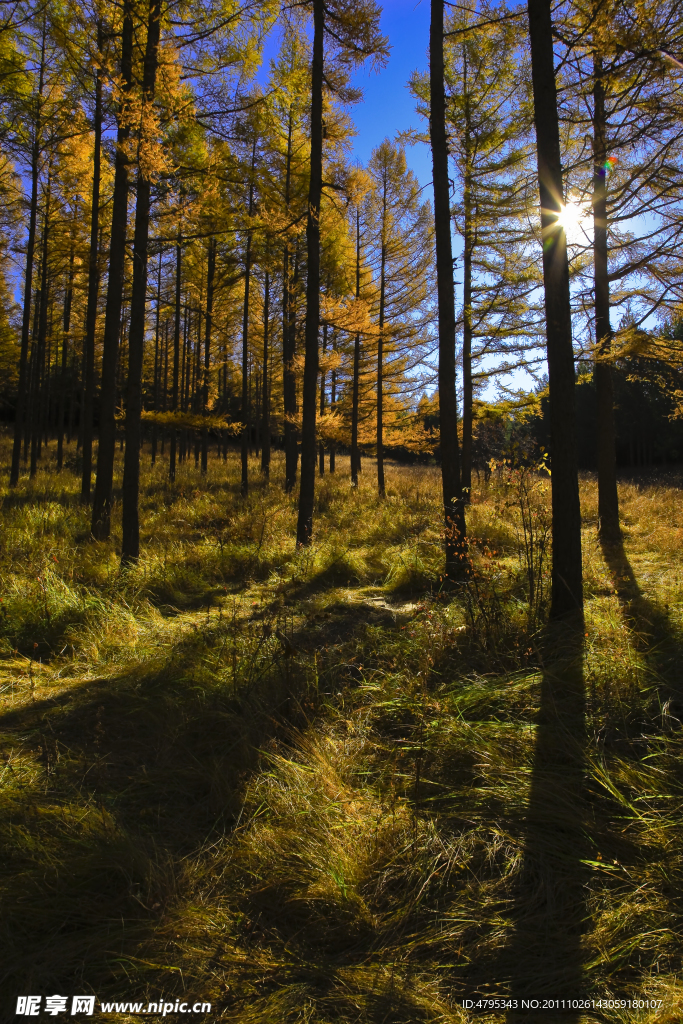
[91,0,133,541]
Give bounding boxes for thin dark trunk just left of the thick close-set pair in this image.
[81,25,102,505]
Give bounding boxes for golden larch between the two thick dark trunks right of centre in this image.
[445,4,540,502]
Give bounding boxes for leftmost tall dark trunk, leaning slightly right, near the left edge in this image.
[9,24,46,487]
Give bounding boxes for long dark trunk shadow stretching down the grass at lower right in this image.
[496,625,590,1024]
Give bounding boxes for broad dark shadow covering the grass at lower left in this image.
[0,620,314,1003]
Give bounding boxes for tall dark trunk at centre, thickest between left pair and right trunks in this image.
[297,0,325,545]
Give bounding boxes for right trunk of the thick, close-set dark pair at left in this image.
[121,0,161,564]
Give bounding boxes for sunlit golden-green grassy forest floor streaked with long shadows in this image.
[0,446,683,1024]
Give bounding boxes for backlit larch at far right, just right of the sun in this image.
[560,3,683,543]
